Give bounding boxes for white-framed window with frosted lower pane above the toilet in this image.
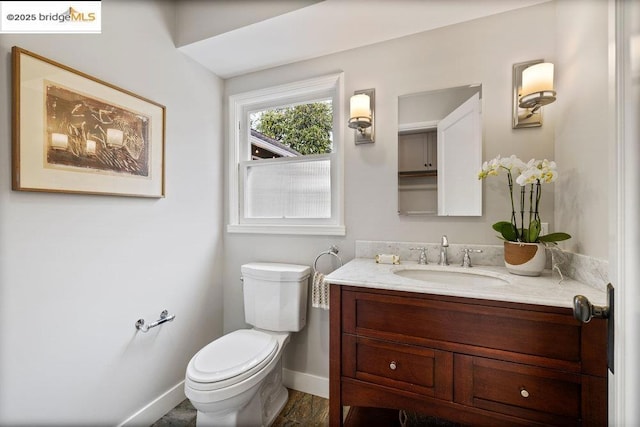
[227,73,345,235]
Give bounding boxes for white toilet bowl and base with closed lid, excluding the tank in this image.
[185,329,289,426]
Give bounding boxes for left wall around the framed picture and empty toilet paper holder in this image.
[0,0,223,425]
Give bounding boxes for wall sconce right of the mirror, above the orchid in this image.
[512,59,556,129]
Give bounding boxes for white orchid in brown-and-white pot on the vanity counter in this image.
[478,155,571,276]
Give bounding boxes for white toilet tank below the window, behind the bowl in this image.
[241,262,311,332]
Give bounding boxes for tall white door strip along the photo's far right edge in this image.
[609,0,640,426]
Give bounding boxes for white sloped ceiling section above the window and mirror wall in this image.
[179,0,550,78]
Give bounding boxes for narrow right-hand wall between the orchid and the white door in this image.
[553,0,615,259]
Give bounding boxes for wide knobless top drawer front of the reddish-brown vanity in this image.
[342,291,581,362]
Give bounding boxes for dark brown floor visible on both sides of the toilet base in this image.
[151,389,329,427]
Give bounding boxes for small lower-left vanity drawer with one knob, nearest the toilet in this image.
[342,334,453,400]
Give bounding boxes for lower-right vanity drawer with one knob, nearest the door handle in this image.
[454,354,582,426]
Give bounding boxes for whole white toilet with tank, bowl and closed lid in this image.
[185,262,311,427]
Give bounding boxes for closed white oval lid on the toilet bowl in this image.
[187,329,278,383]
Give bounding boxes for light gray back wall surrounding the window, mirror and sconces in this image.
[224,3,562,384]
